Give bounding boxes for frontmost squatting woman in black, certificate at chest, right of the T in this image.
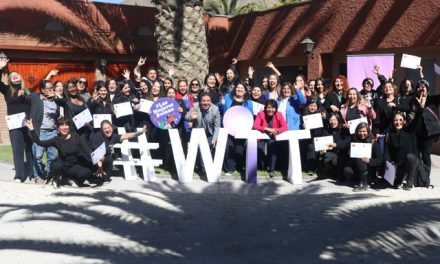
[344,123,383,192]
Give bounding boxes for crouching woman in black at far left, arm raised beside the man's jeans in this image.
[25,119,104,187]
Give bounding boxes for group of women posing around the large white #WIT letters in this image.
[0,55,440,191]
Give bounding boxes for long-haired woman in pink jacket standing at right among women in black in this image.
[340,88,376,128]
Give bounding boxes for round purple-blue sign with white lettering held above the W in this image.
[150,98,182,129]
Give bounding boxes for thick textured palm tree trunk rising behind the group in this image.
[153,0,209,80]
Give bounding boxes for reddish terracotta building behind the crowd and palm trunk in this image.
[0,0,440,143]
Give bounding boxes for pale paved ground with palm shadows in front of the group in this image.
[0,156,440,264]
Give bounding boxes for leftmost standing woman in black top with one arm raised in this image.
[0,58,32,182]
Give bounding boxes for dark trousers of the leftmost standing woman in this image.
[9,128,33,181]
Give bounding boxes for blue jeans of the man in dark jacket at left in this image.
[32,130,58,179]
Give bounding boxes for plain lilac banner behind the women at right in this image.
[347,54,394,91]
